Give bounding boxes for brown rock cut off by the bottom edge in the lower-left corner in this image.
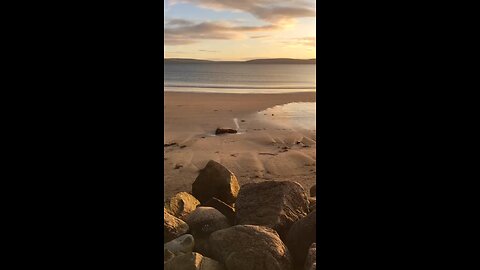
[164,252,225,270]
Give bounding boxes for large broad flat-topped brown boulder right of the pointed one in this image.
[235,181,308,239]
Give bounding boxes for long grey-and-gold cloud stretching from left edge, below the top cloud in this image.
[163,19,278,45]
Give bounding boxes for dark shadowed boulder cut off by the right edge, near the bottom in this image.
[285,210,317,266]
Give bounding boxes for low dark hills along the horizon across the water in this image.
[163,58,317,64]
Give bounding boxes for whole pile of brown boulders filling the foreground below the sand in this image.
[163,160,316,270]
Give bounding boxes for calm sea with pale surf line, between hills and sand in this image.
[164,63,316,93]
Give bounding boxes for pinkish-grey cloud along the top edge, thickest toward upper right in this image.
[170,0,316,23]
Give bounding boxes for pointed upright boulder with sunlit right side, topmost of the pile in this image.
[192,160,240,205]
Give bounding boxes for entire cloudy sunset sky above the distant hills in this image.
[163,0,316,60]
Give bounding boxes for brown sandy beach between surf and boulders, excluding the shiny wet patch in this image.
[164,92,316,198]
